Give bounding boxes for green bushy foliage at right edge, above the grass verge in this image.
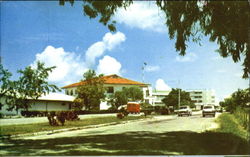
[220,88,250,112]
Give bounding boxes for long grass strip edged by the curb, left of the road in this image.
[0,116,145,136]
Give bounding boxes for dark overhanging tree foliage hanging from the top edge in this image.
[60,0,250,78]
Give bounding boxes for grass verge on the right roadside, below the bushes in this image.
[215,113,248,140]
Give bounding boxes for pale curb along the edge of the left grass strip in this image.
[0,117,156,140]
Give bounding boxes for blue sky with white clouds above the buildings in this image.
[0,1,248,100]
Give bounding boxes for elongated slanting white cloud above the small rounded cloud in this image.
[86,32,126,67]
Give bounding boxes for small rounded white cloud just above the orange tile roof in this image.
[97,56,122,75]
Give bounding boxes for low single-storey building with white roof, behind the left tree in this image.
[0,93,75,115]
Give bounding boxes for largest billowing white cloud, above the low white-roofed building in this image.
[32,46,87,85]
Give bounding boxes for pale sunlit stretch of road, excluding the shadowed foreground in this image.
[25,112,219,139]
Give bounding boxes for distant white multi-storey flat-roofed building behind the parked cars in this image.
[187,89,218,109]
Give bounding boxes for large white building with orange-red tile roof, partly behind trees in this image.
[63,75,153,110]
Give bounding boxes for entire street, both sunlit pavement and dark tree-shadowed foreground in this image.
[0,114,248,155]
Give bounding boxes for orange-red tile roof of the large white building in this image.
[62,75,148,88]
